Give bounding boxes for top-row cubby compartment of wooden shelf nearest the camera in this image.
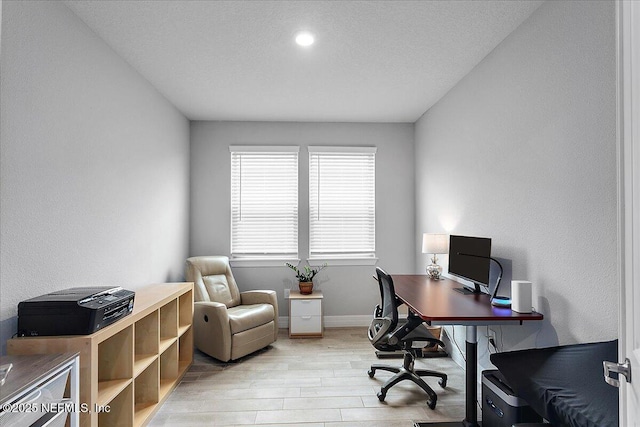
[96,326,133,405]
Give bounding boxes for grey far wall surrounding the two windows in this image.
[189,122,418,324]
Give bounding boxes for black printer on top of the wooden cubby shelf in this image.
[18,287,135,337]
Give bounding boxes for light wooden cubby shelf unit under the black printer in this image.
[7,283,193,427]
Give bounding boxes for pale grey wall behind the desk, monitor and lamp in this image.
[416,1,618,372]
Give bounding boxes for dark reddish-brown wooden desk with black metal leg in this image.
[392,274,543,426]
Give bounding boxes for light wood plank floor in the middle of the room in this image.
[149,328,464,427]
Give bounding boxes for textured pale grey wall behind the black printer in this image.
[0,1,189,349]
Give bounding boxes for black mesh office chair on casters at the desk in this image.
[367,267,447,409]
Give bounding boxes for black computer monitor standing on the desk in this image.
[449,234,491,293]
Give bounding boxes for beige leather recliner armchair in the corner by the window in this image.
[186,256,278,362]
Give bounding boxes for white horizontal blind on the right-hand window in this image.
[309,147,376,258]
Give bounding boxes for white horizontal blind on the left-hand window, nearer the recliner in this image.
[230,146,299,257]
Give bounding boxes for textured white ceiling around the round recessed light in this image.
[65,0,542,122]
